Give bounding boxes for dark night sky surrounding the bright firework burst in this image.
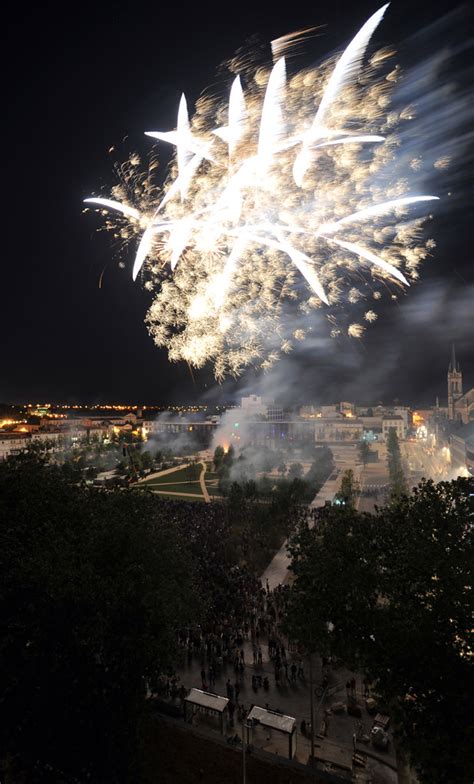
[0,0,474,404]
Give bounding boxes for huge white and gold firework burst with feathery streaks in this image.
[86,5,437,380]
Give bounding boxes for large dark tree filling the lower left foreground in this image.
[0,455,196,784]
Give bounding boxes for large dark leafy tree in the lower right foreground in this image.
[286,479,474,784]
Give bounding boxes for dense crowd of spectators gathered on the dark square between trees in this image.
[150,501,332,720]
